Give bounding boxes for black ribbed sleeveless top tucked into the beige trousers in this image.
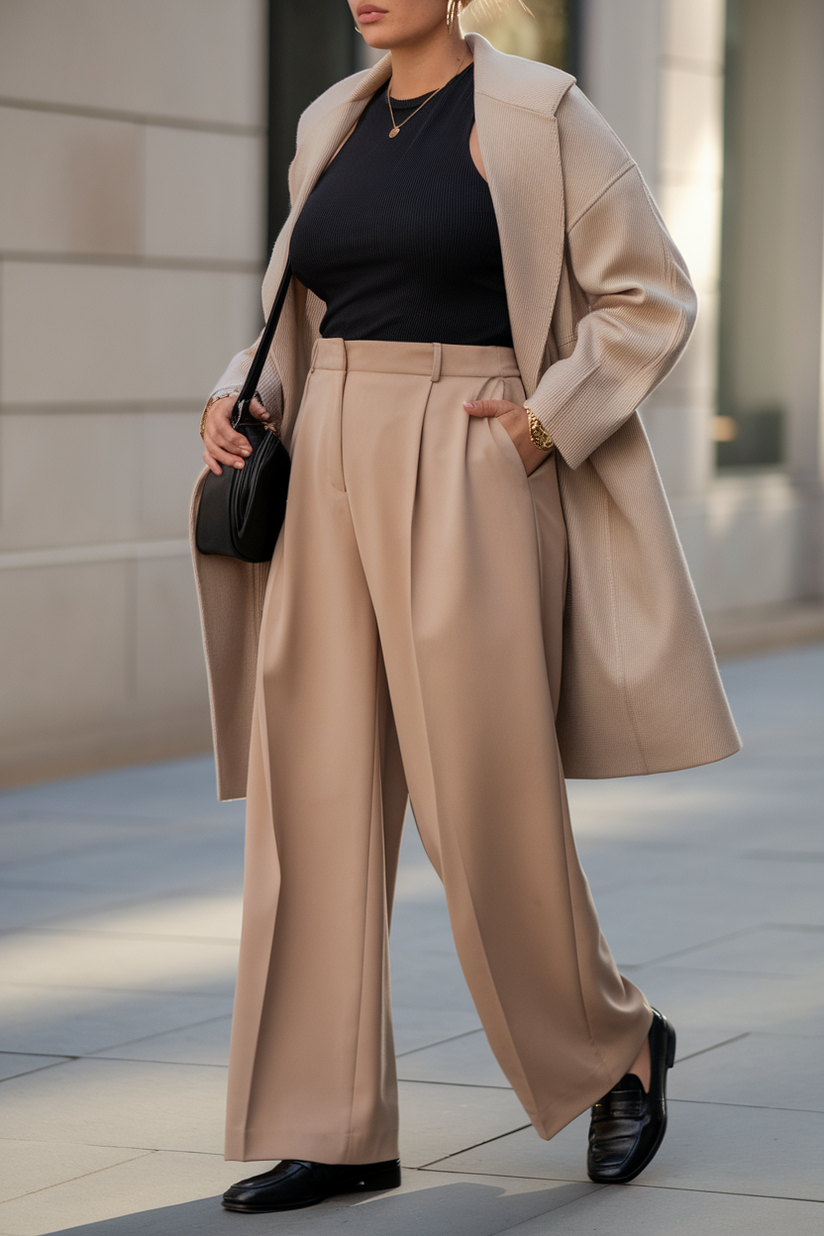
[290,66,513,347]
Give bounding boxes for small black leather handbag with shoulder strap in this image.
[195,266,292,562]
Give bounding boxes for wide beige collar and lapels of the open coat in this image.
[263,35,574,403]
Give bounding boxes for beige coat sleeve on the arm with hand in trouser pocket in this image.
[529,90,697,468]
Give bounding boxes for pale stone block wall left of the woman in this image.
[0,0,266,782]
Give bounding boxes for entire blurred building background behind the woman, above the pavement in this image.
[0,0,824,785]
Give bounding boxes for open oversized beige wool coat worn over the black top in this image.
[193,35,740,798]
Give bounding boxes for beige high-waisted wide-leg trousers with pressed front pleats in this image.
[226,339,651,1163]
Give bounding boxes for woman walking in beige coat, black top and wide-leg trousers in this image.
[195,0,739,1211]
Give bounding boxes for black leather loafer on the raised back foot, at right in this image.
[587,1009,676,1184]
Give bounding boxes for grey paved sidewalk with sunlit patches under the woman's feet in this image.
[0,646,824,1236]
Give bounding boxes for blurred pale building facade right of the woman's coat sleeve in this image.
[582,0,824,625]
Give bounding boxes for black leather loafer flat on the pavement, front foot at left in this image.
[222,1159,400,1215]
